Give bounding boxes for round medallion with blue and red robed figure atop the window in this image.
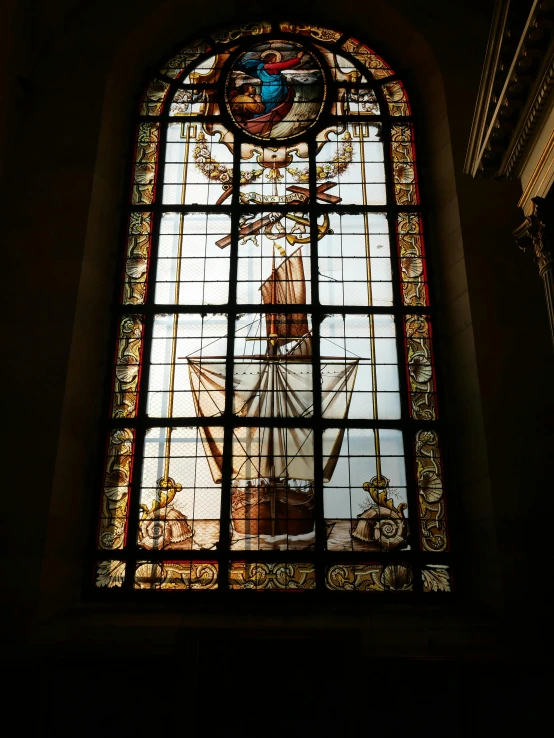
[225,41,325,139]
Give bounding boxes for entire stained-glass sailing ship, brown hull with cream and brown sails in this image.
[187,236,358,548]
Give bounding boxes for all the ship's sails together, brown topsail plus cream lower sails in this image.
[188,244,358,498]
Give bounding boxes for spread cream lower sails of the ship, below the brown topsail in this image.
[189,357,358,483]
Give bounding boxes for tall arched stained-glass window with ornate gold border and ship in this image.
[95,23,451,597]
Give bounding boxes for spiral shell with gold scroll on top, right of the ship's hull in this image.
[352,477,408,551]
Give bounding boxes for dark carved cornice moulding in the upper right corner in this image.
[465,0,554,177]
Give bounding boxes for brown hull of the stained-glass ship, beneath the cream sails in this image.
[232,483,314,536]
